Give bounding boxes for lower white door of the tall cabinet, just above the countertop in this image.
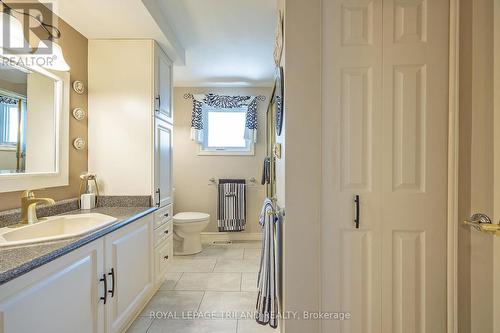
[155,118,173,207]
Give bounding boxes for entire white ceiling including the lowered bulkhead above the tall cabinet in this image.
[41,0,277,87]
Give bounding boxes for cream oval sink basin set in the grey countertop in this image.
[0,213,116,247]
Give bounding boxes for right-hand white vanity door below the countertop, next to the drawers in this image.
[104,215,153,332]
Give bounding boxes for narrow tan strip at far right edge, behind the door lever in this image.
[458,0,494,333]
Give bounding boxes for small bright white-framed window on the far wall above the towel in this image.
[200,106,253,155]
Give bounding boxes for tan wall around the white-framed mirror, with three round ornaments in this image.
[0,6,88,210]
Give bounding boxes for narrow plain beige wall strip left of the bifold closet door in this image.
[279,0,321,333]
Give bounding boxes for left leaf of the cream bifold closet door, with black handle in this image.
[321,0,382,333]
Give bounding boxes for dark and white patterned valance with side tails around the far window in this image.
[191,94,259,143]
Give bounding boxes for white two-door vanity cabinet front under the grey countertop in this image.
[0,214,157,333]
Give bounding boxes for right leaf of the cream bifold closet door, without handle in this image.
[381,0,449,333]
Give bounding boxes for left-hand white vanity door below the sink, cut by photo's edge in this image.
[0,240,106,333]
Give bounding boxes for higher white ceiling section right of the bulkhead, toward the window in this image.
[157,0,277,86]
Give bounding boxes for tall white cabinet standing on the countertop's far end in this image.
[88,40,173,207]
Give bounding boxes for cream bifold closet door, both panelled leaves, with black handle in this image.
[322,0,449,333]
